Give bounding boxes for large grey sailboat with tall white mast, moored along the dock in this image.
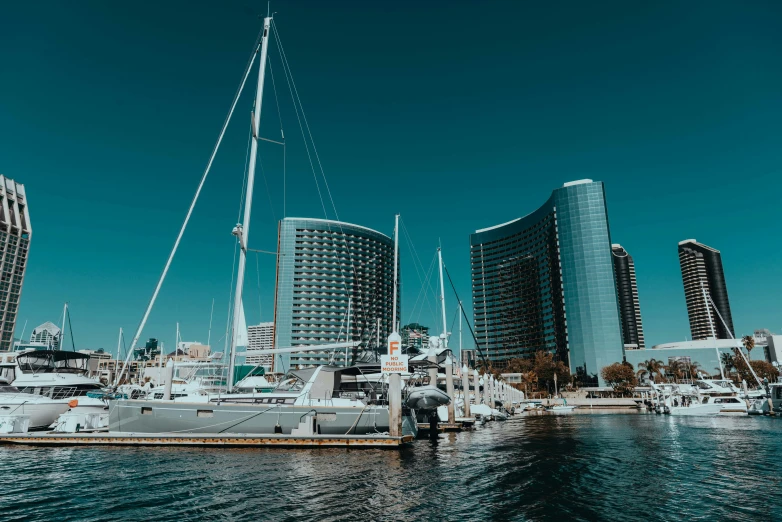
[109,16,422,435]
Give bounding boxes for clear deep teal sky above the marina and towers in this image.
[0,1,782,350]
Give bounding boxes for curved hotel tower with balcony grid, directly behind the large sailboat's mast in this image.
[274,218,401,372]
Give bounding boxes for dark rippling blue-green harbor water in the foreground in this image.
[0,414,782,522]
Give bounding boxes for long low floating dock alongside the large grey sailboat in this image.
[0,432,413,449]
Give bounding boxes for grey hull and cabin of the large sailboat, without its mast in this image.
[109,366,417,436]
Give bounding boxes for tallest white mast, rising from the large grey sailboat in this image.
[228,16,272,392]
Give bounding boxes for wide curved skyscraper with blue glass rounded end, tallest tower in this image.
[470,180,623,384]
